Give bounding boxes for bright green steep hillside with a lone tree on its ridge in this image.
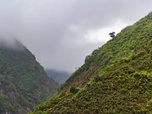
[33,13,152,114]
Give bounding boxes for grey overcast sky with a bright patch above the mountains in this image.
[0,0,152,72]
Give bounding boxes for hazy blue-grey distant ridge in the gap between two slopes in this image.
[45,69,70,84]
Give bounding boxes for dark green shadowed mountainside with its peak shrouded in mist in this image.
[0,40,58,114]
